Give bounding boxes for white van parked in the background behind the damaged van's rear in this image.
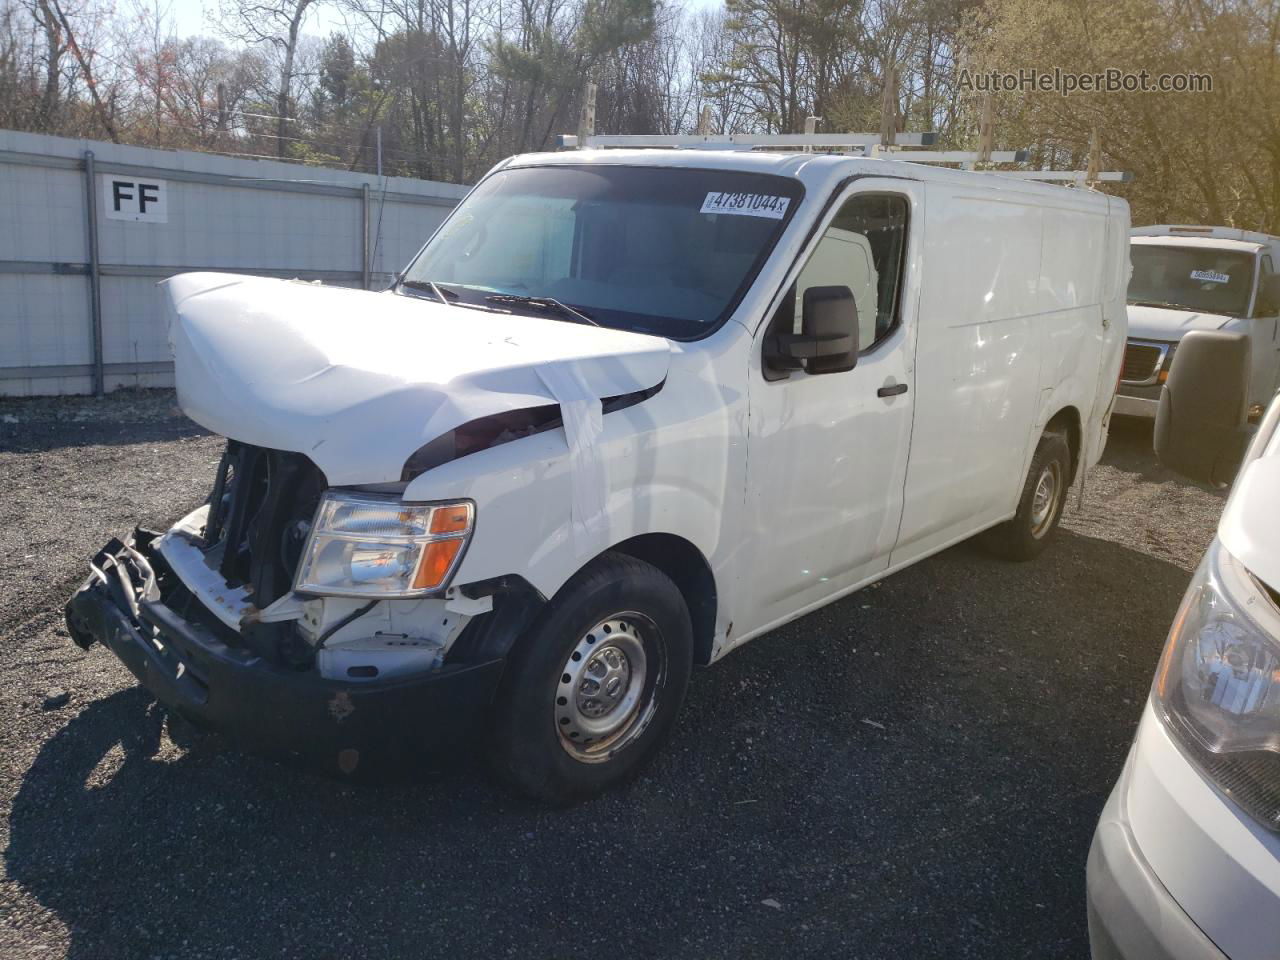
[1115,224,1280,420]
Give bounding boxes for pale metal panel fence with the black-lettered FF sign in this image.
[0,131,468,396]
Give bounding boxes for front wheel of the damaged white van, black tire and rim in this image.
[490,553,694,804]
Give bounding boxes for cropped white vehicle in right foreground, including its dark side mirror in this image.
[1088,332,1280,960]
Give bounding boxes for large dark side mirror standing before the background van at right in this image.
[1156,330,1249,486]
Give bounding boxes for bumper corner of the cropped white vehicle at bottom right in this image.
[1087,759,1229,960]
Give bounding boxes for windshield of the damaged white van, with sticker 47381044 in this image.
[404,164,803,339]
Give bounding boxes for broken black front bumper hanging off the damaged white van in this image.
[67,530,503,776]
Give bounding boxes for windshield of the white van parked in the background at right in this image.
[1129,243,1254,316]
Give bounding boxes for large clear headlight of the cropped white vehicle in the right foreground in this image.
[1152,540,1280,831]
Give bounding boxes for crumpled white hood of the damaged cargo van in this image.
[164,273,671,485]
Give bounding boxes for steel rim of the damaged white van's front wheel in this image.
[553,612,666,763]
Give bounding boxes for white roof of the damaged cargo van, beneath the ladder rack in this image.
[495,148,1124,212]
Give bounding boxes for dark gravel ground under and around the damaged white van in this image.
[0,393,1222,960]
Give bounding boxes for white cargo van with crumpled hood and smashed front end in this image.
[68,150,1129,800]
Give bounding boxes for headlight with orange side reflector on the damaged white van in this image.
[293,493,475,598]
